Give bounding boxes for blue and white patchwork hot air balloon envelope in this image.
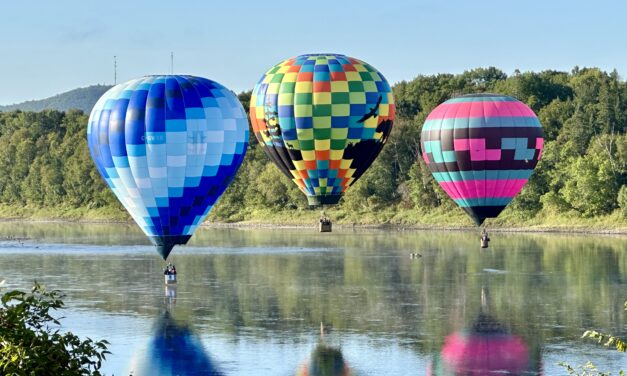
[87,75,248,259]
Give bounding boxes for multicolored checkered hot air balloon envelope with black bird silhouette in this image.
[250,54,395,205]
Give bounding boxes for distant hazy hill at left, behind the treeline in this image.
[0,85,111,114]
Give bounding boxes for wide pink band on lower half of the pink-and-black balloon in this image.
[439,179,527,200]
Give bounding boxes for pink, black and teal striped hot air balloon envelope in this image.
[421,94,544,226]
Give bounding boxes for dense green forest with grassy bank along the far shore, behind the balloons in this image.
[0,67,627,228]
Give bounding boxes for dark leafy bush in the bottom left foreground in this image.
[0,283,110,376]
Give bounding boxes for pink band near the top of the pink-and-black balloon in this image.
[427,102,536,120]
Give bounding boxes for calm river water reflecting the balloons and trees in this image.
[0,222,627,376]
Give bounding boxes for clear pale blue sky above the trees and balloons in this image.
[0,0,627,104]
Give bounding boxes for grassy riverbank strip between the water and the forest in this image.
[0,205,627,234]
